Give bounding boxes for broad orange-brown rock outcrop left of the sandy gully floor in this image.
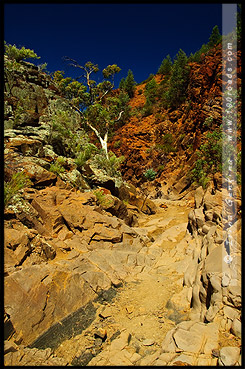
[5,187,147,345]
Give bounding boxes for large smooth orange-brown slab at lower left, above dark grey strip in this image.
[5,265,95,344]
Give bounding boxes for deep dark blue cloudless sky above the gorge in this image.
[4,3,222,83]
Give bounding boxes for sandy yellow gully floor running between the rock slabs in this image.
[53,200,190,365]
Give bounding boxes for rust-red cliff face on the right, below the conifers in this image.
[110,46,241,184]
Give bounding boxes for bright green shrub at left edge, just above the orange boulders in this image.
[4,171,31,206]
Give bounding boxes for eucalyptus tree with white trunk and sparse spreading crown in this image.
[53,57,124,159]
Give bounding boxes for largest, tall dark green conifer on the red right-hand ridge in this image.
[164,49,190,108]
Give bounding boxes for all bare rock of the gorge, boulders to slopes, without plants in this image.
[4,51,241,366]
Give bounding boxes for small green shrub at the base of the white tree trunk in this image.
[93,151,125,177]
